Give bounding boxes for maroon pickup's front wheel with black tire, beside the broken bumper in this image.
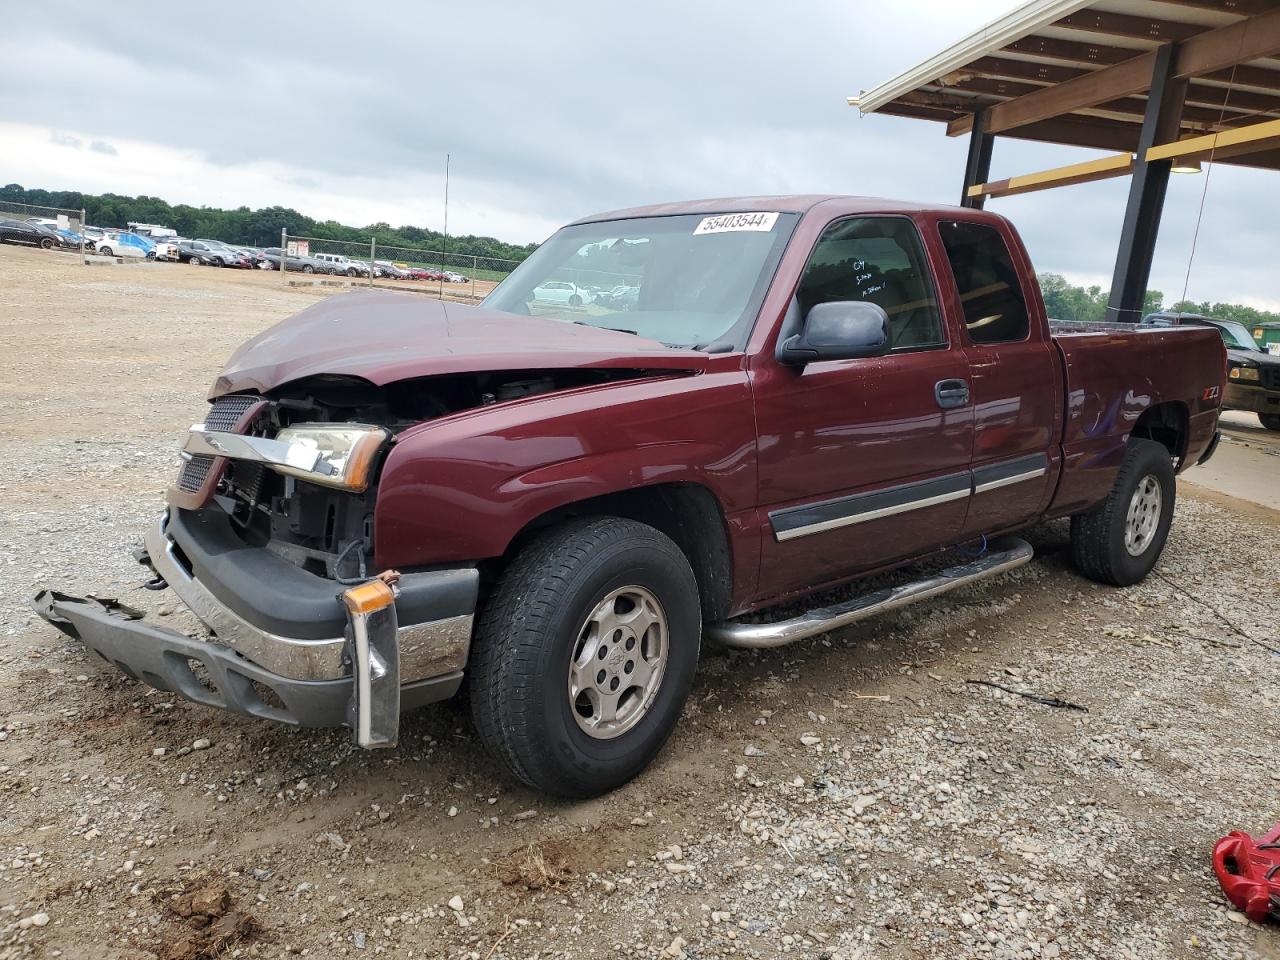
[467,517,701,797]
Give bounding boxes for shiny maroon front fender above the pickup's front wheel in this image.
[374,355,756,571]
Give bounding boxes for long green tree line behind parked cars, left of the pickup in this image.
[0,183,538,260]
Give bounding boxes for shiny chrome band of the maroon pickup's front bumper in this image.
[145,511,477,684]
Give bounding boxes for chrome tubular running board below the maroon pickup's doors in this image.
[704,536,1036,650]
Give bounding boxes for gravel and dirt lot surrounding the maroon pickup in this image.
[0,247,1280,960]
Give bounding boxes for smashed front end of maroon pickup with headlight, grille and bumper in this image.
[27,373,550,748]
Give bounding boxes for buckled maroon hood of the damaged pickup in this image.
[209,292,709,399]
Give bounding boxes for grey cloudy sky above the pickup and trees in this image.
[0,0,1280,308]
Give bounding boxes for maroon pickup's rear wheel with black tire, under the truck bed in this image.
[1071,440,1176,586]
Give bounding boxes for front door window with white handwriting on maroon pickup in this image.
[796,216,946,349]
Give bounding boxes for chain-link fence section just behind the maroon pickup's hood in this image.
[280,230,520,300]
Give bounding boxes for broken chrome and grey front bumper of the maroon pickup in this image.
[35,509,479,727]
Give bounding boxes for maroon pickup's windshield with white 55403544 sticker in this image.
[484,212,797,348]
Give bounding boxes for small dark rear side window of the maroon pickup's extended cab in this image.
[938,220,1030,343]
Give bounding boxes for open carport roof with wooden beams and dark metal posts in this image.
[849,0,1280,321]
